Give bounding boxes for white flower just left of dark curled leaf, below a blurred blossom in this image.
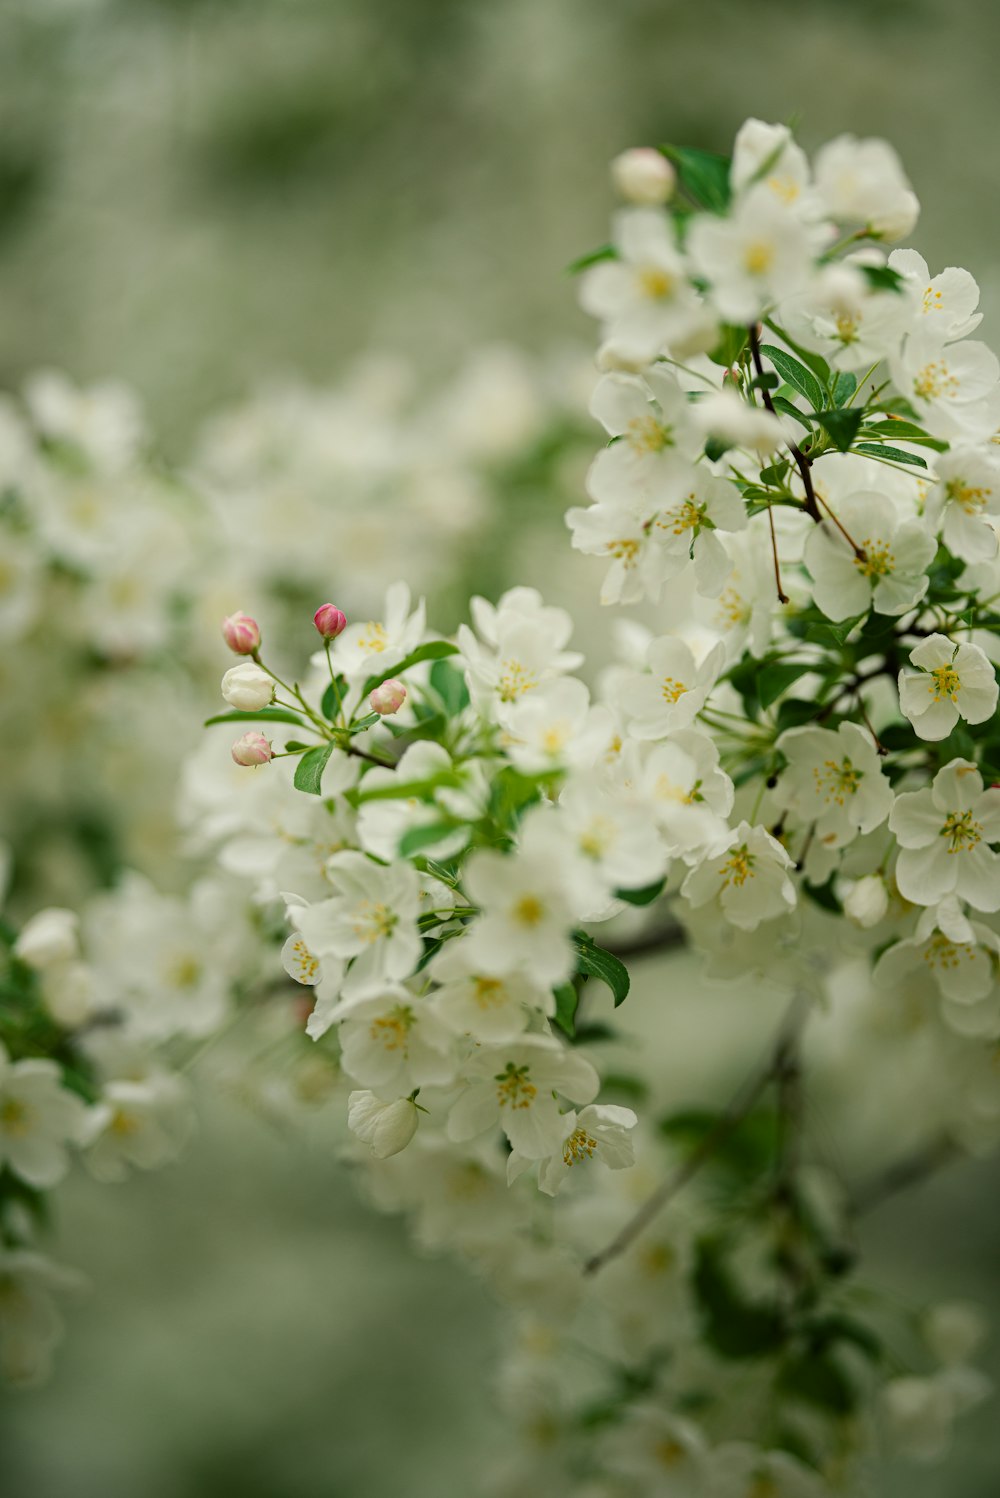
[427,941,555,1044]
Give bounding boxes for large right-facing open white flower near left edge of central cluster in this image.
[289,852,422,996]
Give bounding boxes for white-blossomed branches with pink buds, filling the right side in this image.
[0,120,1000,1498]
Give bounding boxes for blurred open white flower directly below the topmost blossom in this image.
[687,184,811,322]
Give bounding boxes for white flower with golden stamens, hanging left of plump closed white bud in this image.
[681,822,795,932]
